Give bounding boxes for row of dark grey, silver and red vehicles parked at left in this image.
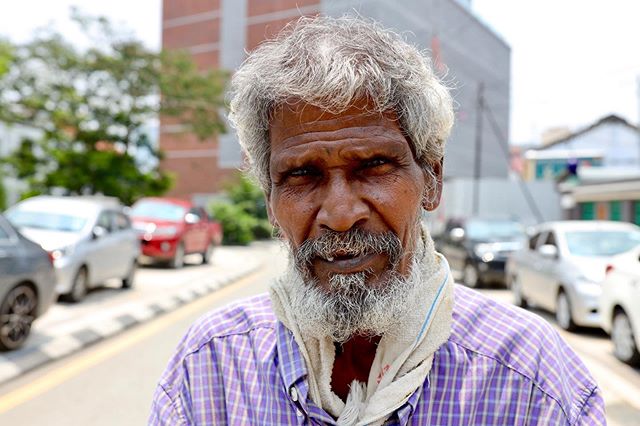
[0,196,222,350]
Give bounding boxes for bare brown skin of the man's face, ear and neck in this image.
[267,102,442,400]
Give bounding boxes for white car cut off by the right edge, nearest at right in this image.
[600,249,640,365]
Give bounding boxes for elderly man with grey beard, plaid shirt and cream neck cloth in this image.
[150,18,604,425]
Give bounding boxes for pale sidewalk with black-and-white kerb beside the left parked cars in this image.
[0,243,269,384]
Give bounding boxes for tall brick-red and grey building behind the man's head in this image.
[160,0,511,198]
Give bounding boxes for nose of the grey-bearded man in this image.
[317,174,371,232]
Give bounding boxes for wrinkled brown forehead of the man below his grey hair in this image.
[269,101,402,146]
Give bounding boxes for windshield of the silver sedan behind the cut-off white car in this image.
[566,230,640,256]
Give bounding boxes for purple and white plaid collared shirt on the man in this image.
[149,285,606,425]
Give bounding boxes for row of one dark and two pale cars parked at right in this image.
[435,218,640,364]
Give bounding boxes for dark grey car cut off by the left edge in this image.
[0,215,56,351]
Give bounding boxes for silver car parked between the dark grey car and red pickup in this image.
[6,196,140,302]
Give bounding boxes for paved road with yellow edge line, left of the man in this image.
[0,241,284,426]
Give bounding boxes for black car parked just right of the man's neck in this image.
[437,218,526,287]
